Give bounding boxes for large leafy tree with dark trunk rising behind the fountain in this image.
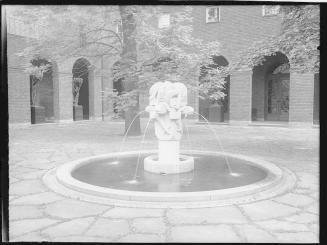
[7,6,223,134]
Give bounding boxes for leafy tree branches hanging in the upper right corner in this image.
[233,5,320,72]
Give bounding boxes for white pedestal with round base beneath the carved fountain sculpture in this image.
[144,140,194,174]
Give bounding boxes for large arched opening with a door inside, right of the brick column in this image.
[252,52,290,121]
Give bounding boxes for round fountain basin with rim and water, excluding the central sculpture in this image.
[44,151,295,207]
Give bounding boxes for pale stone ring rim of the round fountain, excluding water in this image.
[43,150,295,207]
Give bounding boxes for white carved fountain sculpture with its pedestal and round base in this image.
[144,81,194,174]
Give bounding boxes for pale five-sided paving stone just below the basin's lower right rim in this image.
[240,200,300,220]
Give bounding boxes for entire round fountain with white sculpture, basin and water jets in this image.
[43,81,295,208]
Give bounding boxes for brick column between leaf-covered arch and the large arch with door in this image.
[229,70,252,124]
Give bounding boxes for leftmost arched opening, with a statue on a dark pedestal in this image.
[30,58,55,124]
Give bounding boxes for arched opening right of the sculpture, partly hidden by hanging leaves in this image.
[199,56,230,122]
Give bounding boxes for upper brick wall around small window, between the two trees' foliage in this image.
[193,5,281,63]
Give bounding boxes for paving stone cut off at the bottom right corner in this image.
[274,232,319,243]
